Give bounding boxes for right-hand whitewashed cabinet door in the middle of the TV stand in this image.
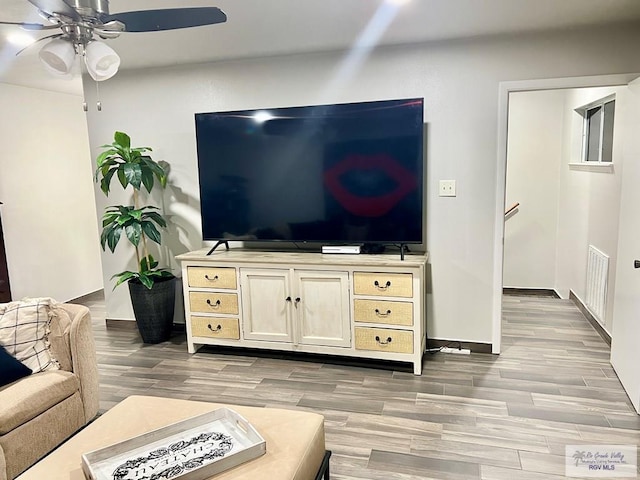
[294,270,351,347]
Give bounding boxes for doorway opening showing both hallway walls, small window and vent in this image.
[503,86,628,343]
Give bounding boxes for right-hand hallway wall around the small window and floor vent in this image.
[556,87,627,334]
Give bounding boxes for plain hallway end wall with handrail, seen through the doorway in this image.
[503,90,565,289]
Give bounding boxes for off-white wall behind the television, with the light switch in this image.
[85,27,640,343]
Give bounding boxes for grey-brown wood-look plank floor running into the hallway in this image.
[84,295,640,480]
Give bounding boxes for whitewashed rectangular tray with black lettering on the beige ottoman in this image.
[82,408,267,480]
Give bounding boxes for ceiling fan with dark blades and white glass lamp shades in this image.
[0,0,227,81]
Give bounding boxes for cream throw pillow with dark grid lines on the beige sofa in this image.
[0,298,59,373]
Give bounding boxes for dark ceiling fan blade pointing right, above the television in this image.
[100,7,227,32]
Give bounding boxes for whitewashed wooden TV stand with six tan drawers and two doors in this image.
[176,246,428,375]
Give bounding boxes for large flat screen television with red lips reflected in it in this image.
[195,98,424,245]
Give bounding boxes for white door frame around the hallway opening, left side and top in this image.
[491,73,640,354]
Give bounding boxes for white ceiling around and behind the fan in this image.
[0,0,640,93]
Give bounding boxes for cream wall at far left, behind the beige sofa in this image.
[0,84,103,301]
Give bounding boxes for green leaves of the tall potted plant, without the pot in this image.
[95,132,173,289]
